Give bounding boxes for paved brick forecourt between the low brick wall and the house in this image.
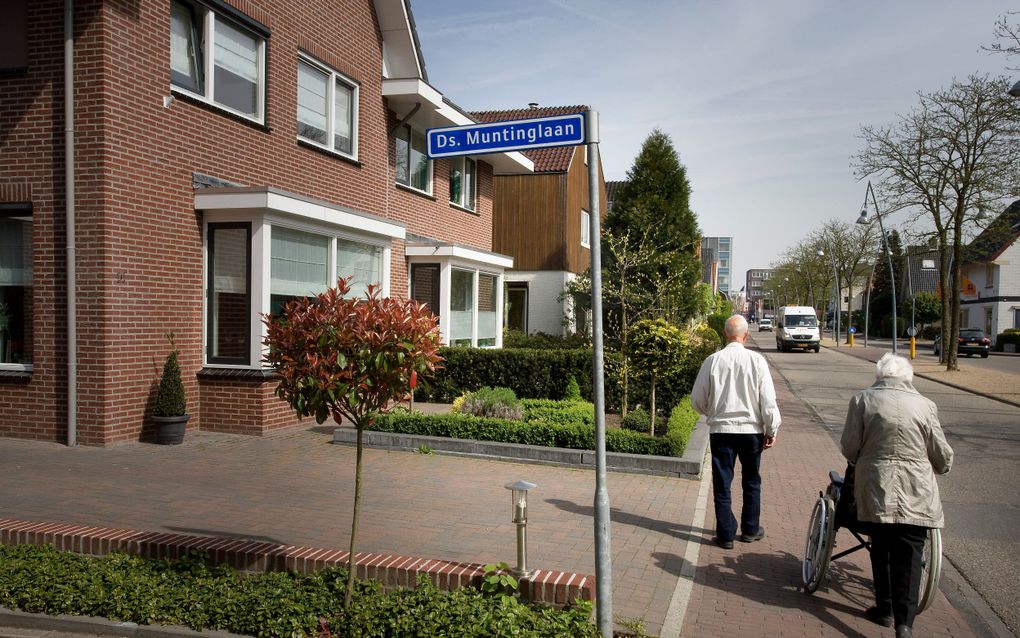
[0,420,710,633]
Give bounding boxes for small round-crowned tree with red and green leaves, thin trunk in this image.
[262,279,441,607]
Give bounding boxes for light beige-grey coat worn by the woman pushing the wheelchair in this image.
[840,379,953,528]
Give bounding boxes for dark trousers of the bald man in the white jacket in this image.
[709,433,765,541]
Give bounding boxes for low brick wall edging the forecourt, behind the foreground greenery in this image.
[0,519,595,606]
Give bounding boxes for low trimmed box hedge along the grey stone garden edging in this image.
[369,398,698,457]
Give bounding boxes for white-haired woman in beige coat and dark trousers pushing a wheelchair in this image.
[840,354,953,638]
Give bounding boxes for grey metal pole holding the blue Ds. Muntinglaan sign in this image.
[584,109,613,638]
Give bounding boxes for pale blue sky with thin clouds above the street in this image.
[411,0,1020,290]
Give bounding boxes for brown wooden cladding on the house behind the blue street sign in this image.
[493,146,606,273]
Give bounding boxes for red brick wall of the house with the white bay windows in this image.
[0,0,492,445]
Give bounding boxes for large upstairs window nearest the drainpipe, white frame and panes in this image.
[170,1,265,121]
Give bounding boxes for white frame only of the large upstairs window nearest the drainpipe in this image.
[170,0,266,125]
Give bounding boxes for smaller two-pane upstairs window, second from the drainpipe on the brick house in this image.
[298,59,358,157]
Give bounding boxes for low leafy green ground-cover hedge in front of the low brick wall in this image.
[0,545,599,638]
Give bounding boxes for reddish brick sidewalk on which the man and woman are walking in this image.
[681,361,974,638]
